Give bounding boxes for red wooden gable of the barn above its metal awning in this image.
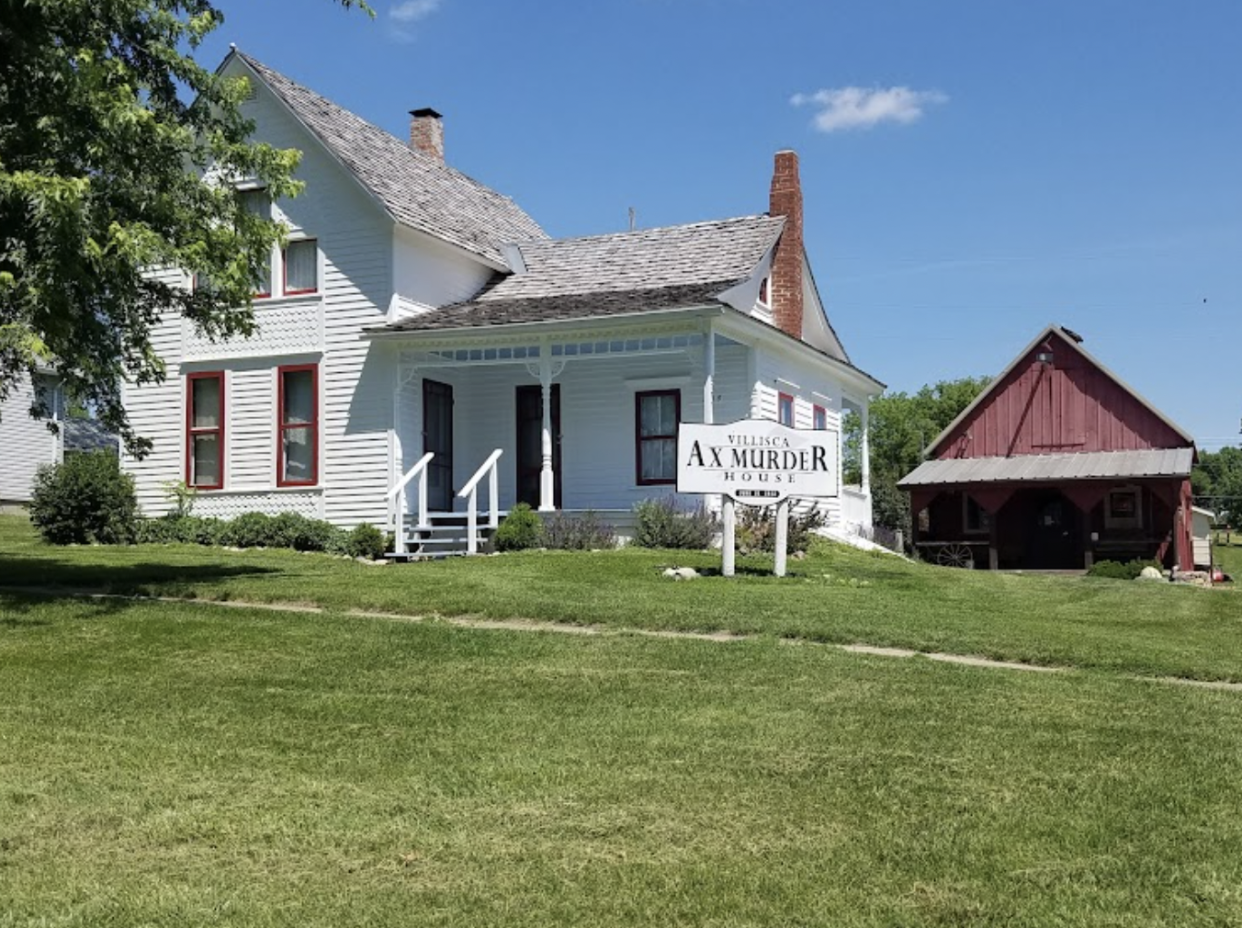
[927,325,1195,458]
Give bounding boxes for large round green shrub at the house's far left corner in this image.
[30,451,138,544]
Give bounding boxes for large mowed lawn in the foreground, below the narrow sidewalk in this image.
[0,596,1242,928]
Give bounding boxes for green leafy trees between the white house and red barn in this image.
[843,376,991,537]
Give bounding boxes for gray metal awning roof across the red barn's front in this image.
[897,448,1195,487]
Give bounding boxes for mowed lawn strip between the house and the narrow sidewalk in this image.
[0,517,1242,680]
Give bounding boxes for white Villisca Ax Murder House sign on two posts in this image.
[677,419,841,576]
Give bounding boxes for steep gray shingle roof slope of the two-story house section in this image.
[236,52,545,262]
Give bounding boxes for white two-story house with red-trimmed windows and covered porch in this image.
[125,51,883,551]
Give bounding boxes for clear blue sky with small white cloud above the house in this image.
[202,0,1242,450]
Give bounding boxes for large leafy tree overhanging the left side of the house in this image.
[0,0,370,453]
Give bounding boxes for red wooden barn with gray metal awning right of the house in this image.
[898,325,1195,570]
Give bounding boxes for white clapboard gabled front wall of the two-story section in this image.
[127,70,394,525]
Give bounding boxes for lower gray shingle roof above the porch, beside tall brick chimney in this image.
[389,216,785,332]
